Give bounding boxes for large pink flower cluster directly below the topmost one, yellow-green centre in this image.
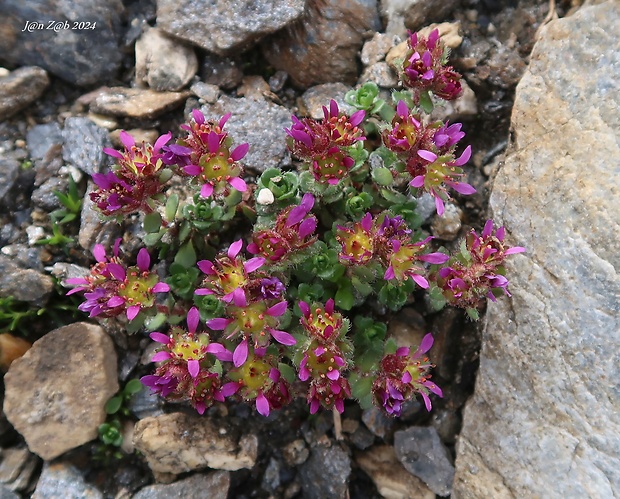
[382,100,476,215]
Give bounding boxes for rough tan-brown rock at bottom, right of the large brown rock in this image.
[134,412,258,474]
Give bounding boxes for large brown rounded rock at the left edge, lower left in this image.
[4,322,118,460]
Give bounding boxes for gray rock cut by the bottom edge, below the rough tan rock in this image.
[132,471,230,499]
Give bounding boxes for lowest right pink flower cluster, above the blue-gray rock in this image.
[372,333,443,416]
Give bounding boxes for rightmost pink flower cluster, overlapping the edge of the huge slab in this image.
[436,220,525,310]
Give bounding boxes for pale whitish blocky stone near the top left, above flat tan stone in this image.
[136,28,198,92]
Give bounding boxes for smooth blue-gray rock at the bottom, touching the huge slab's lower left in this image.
[394,427,454,496]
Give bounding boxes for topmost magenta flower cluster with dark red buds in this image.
[401,29,462,100]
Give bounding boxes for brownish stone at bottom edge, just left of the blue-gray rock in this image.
[355,445,435,499]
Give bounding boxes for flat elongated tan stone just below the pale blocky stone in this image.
[90,87,191,119]
